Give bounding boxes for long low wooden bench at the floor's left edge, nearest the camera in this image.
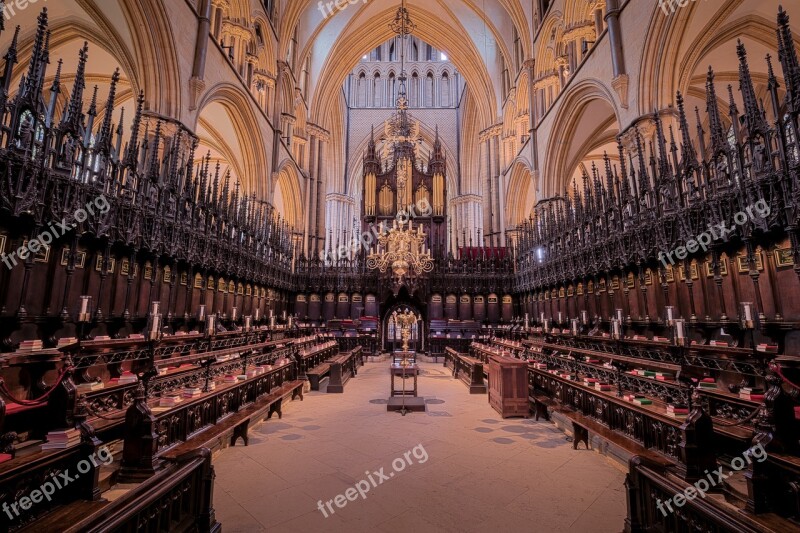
[161,380,303,460]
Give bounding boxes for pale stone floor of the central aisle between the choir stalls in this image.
[214,363,625,533]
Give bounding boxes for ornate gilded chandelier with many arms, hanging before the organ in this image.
[367,220,433,293]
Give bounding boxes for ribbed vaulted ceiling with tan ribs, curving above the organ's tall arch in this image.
[281,0,531,126]
